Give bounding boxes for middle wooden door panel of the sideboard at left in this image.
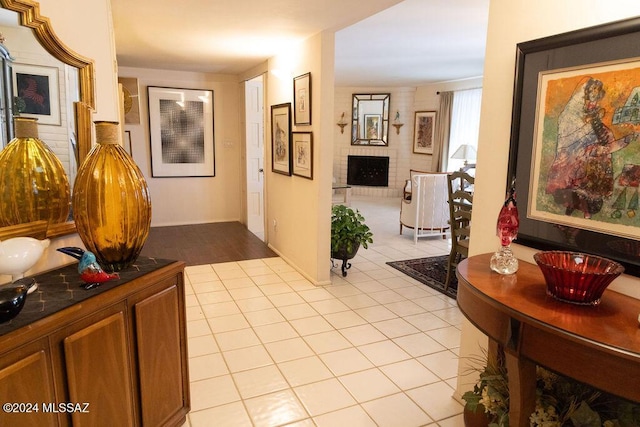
[63,312,134,427]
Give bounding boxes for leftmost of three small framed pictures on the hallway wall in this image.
[271,102,291,175]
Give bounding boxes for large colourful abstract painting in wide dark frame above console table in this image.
[508,18,640,275]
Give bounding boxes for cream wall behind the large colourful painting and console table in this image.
[457,0,640,400]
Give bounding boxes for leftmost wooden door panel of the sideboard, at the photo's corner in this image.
[0,340,58,426]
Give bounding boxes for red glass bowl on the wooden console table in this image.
[533,251,624,305]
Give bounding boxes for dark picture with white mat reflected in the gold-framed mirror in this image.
[11,64,61,126]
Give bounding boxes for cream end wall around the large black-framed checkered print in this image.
[118,67,244,227]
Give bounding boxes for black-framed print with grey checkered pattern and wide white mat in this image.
[147,86,215,177]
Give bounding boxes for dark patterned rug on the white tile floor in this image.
[387,255,458,299]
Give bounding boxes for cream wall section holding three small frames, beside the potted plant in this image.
[265,33,335,284]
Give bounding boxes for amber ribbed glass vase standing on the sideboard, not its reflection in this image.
[73,122,151,271]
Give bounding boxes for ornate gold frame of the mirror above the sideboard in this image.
[0,0,95,240]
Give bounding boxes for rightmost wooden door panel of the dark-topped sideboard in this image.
[134,285,187,426]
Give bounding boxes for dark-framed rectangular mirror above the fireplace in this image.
[351,93,391,145]
